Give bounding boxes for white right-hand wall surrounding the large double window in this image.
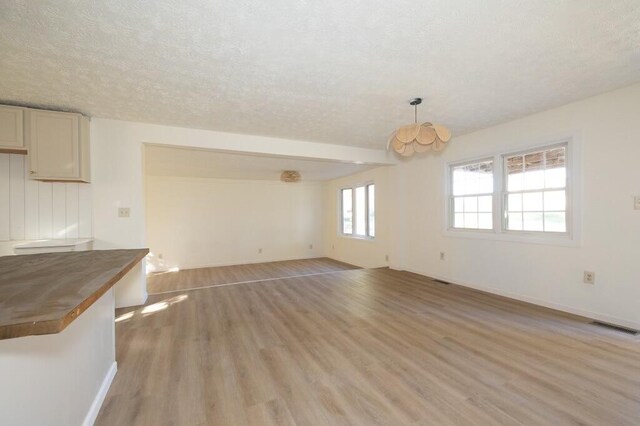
[393,85,640,328]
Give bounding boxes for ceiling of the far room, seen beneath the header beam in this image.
[145,145,375,181]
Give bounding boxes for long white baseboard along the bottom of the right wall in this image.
[404,268,640,330]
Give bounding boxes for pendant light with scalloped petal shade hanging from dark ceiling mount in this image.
[387,98,451,157]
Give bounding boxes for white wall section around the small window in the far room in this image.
[324,166,394,268]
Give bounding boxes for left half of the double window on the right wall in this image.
[449,160,493,229]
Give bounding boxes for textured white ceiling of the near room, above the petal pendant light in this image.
[0,0,640,148]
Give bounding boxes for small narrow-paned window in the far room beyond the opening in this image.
[340,183,376,238]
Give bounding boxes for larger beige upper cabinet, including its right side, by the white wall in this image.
[26,110,91,182]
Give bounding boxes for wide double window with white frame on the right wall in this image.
[447,142,573,238]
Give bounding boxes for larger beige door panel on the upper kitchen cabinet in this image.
[29,111,80,180]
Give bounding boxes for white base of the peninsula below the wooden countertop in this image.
[0,291,116,426]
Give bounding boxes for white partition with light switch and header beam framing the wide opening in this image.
[91,118,395,306]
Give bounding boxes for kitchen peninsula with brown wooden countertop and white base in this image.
[0,249,148,425]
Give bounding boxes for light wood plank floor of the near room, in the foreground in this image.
[96,269,640,426]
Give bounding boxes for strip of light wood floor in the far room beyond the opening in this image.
[147,257,358,294]
